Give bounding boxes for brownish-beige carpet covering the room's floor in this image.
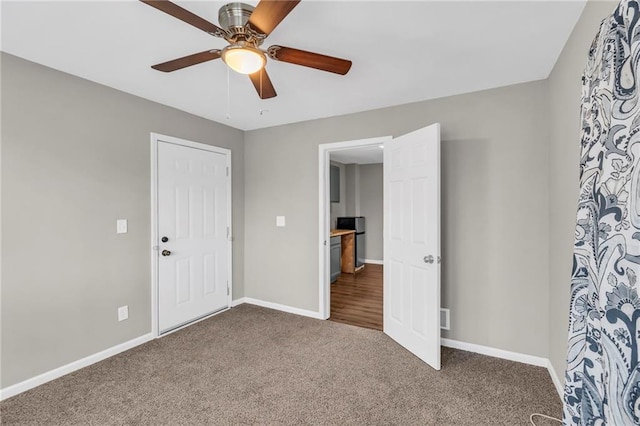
[0,305,561,425]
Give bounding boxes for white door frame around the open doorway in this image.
[318,136,392,319]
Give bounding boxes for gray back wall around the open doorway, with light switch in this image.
[245,81,549,357]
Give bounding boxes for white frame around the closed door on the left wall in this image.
[150,132,233,337]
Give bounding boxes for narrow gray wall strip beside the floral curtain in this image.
[548,1,617,380]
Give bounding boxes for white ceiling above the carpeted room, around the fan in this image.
[1,0,585,130]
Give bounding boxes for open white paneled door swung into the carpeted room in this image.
[383,124,440,370]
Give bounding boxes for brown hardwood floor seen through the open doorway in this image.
[329,263,382,330]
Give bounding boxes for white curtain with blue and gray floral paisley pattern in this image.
[564,1,640,425]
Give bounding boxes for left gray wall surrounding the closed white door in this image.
[1,54,244,387]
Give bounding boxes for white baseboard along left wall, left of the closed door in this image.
[0,333,154,401]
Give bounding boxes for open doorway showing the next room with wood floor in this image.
[329,144,384,331]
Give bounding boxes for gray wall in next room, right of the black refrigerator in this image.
[358,164,383,260]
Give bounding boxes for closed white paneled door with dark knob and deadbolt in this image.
[158,141,230,333]
